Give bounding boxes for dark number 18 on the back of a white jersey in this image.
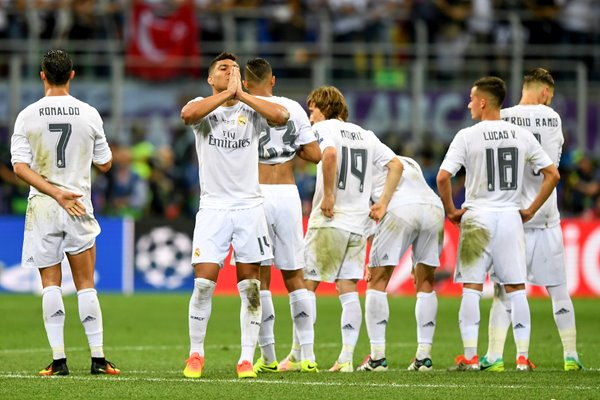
[485,147,519,192]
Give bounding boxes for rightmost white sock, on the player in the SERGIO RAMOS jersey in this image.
[546,284,579,360]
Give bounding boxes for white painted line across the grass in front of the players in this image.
[0,374,599,390]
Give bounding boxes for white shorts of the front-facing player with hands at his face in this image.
[192,204,273,267]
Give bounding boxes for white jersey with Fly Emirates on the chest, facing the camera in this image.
[192,97,267,209]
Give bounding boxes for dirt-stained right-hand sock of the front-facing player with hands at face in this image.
[238,279,262,364]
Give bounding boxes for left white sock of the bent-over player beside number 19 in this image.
[365,289,390,360]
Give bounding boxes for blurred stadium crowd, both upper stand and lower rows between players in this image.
[0,0,600,218]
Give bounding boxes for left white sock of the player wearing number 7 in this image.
[42,286,67,360]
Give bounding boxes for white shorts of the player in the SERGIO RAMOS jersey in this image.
[492,225,567,286]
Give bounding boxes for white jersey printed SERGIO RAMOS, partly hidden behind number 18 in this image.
[500,104,565,228]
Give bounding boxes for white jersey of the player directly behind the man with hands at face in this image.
[256,96,317,164]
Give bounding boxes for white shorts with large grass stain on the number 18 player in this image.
[454,210,525,284]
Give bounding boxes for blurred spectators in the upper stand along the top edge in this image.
[0,0,600,80]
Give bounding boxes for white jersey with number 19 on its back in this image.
[308,119,395,235]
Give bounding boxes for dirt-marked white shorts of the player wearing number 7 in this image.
[21,195,100,268]
